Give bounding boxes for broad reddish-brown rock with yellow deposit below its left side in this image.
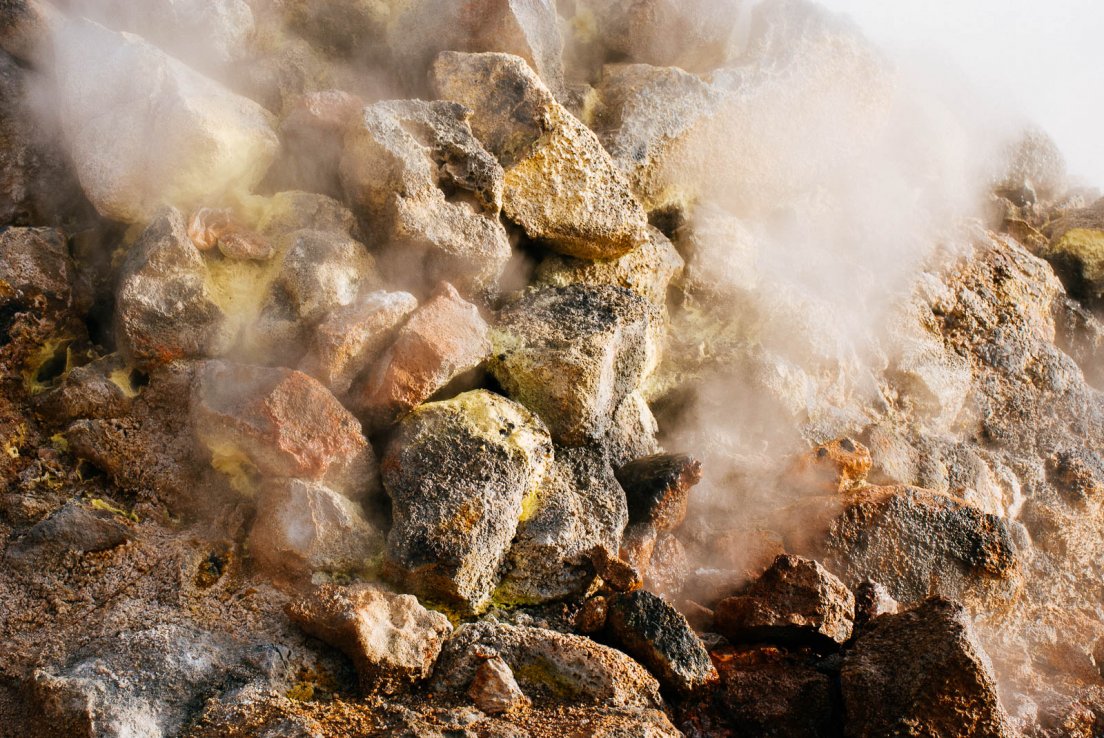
[191,361,376,498]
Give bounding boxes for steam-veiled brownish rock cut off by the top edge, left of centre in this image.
[388,0,563,92]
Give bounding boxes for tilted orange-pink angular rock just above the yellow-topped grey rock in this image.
[353,283,490,428]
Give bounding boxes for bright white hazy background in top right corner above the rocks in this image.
[820,0,1104,187]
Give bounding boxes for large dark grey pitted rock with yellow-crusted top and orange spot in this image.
[382,390,552,612]
